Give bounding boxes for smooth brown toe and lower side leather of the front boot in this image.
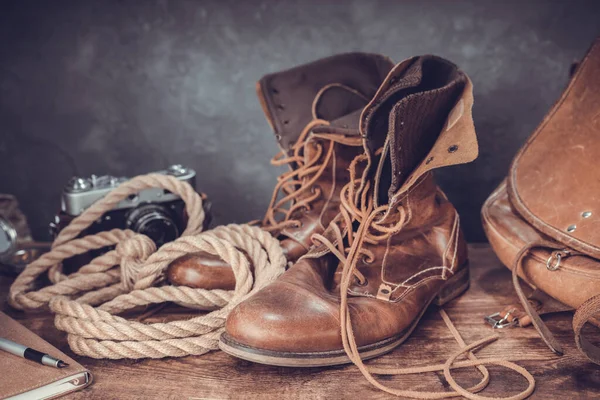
[226,258,454,353]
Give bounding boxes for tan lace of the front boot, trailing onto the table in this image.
[311,155,548,400]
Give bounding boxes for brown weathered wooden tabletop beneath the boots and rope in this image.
[0,245,600,399]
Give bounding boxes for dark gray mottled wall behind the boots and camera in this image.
[0,0,600,241]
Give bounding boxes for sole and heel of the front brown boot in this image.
[219,265,469,367]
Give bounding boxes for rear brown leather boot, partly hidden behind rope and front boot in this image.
[168,53,393,289]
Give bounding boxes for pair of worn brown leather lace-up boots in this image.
[171,53,478,366]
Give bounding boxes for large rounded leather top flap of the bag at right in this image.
[508,39,600,258]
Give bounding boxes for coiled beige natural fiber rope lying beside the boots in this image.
[9,174,286,359]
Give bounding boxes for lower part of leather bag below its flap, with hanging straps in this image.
[482,182,600,359]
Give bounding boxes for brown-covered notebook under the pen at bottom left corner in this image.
[0,312,92,400]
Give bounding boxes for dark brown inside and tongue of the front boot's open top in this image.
[363,56,467,197]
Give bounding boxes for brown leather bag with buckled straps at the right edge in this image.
[482,38,600,364]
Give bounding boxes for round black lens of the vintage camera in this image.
[126,204,179,247]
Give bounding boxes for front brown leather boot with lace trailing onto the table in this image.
[220,56,478,366]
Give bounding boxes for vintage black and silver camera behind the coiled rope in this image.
[50,165,196,272]
